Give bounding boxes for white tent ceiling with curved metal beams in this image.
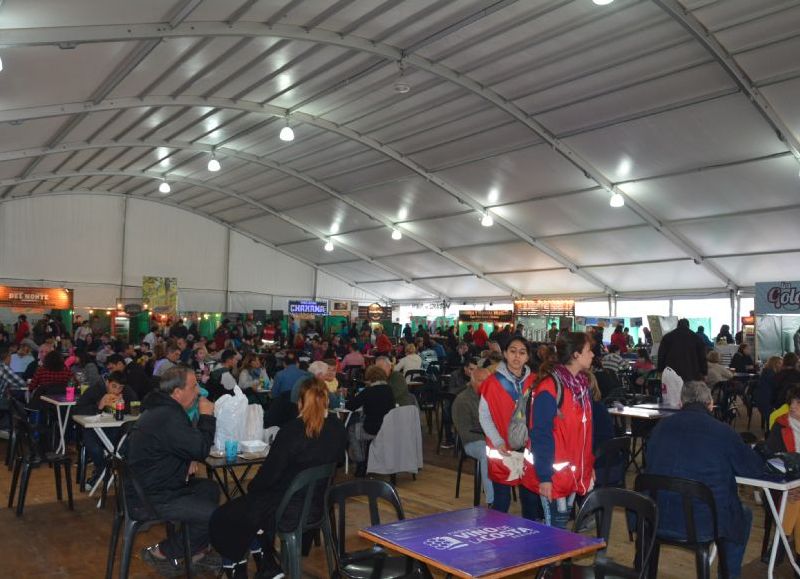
[0,0,800,300]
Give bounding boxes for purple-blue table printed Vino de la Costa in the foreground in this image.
[358,507,605,579]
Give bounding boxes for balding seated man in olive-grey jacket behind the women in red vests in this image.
[453,368,494,507]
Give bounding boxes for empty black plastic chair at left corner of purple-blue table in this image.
[323,479,415,579]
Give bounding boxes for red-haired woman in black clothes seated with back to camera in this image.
[209,378,347,579]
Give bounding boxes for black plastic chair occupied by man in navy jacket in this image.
[635,474,728,579]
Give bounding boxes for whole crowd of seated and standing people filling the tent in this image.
[0,308,800,577]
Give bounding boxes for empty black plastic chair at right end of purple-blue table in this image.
[556,488,658,579]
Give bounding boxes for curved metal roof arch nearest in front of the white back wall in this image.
[0,171,445,298]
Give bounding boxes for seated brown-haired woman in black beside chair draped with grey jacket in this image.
[347,365,395,477]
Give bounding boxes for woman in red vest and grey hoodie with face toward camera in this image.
[478,336,541,519]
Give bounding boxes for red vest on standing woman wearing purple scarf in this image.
[522,378,594,499]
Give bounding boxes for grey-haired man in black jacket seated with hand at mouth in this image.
[127,366,219,562]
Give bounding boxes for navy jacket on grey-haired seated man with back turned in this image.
[646,404,764,543]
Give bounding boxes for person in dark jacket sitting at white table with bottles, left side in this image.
[72,372,139,490]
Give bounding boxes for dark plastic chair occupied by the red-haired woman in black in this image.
[275,462,336,579]
